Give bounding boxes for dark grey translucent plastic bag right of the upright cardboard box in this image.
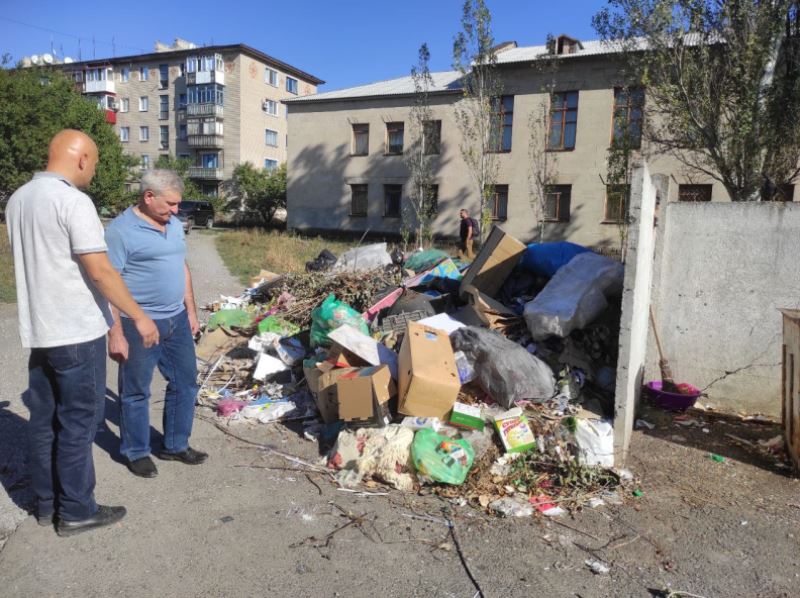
[450,326,556,409]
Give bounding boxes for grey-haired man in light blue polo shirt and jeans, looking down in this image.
[106,170,208,478]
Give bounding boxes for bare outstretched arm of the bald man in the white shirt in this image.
[78,251,158,347]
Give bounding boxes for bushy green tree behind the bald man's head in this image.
[0,57,135,208]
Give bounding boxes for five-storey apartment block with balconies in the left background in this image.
[61,40,324,195]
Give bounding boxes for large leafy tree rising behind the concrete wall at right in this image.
[593,0,800,201]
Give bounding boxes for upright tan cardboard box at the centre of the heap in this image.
[398,322,461,420]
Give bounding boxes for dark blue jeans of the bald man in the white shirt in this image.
[27,336,106,521]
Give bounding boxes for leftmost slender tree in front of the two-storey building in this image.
[403,44,440,249]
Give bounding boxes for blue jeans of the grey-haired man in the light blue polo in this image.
[119,310,197,461]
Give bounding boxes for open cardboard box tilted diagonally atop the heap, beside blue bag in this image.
[459,226,525,300]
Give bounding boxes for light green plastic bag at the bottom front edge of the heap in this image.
[411,428,475,486]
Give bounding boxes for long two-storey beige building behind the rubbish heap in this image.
[285,36,794,247]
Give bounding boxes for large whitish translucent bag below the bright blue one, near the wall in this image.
[523,252,625,341]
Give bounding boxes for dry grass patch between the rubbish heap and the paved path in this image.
[214,229,357,286]
